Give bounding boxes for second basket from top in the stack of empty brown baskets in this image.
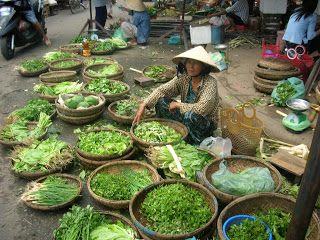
[253,66,300,80]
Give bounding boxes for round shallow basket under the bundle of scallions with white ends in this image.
[24,173,83,211]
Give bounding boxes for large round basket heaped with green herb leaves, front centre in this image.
[129,180,218,240]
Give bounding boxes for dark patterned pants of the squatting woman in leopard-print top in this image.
[155,97,217,145]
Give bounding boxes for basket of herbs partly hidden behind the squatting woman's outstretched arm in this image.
[108,97,156,125]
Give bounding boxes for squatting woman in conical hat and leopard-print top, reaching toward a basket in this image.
[132,46,219,145]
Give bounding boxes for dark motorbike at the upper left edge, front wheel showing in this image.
[0,0,47,60]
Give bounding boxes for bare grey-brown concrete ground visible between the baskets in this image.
[0,1,315,240]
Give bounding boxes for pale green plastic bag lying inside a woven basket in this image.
[211,160,274,196]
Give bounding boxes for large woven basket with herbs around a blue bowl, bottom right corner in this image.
[217,193,320,240]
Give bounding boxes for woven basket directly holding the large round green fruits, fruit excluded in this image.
[55,93,106,118]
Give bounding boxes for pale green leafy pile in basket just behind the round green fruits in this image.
[84,78,127,94]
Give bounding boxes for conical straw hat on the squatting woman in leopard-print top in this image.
[172,46,219,71]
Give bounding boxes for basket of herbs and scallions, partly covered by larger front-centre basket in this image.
[87,160,161,209]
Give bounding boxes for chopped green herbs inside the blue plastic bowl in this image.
[227,219,269,240]
